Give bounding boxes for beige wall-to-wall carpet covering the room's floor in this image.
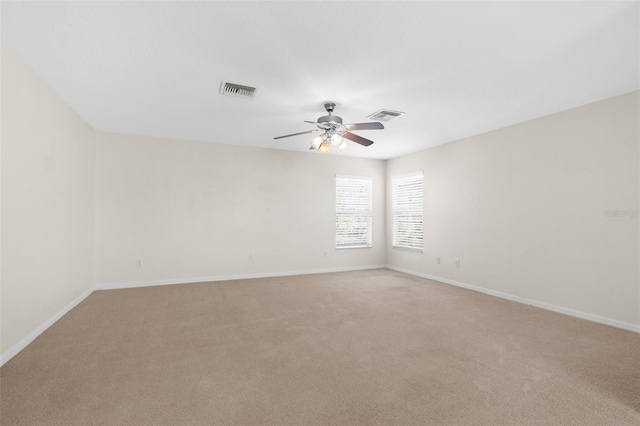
[0,269,640,425]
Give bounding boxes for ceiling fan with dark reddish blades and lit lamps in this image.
[274,102,384,153]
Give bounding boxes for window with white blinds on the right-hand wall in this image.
[391,172,423,251]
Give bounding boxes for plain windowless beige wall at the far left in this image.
[0,45,95,354]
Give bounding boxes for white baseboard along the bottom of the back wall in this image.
[95,265,386,290]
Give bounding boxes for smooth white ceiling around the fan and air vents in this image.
[1,1,640,159]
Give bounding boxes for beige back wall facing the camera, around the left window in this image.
[95,133,385,287]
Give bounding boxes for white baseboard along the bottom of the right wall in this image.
[387,265,640,333]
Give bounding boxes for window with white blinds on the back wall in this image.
[336,175,373,248]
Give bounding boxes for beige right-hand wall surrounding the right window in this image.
[386,92,640,325]
